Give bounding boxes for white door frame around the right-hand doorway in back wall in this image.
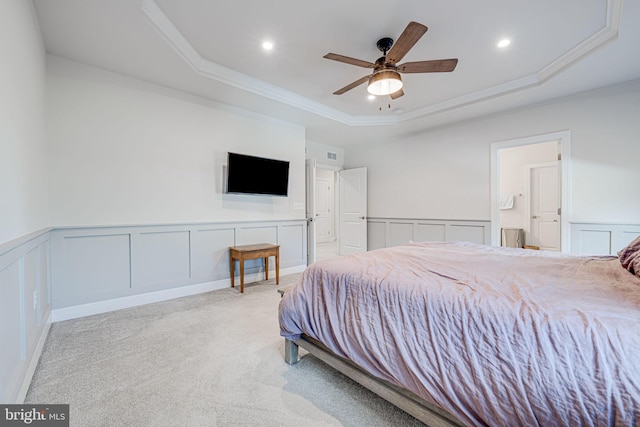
[491,130,571,252]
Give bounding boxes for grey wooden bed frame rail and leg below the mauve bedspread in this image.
[284,335,464,427]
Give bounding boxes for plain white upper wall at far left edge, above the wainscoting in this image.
[0,0,48,245]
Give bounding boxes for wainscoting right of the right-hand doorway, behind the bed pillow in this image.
[571,223,640,255]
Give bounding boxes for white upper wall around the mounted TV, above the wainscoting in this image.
[46,56,305,226]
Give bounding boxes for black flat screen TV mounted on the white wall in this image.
[227,152,289,196]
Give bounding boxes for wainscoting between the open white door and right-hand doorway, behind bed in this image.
[367,218,491,250]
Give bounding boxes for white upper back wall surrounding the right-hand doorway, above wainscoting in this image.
[345,80,640,223]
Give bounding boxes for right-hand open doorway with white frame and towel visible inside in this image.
[491,131,571,252]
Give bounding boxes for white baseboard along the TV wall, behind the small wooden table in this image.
[51,265,306,322]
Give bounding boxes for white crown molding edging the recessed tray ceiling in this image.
[142,0,623,126]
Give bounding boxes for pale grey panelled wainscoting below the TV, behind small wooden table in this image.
[51,220,307,321]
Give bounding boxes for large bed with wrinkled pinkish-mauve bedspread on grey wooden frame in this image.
[279,238,640,426]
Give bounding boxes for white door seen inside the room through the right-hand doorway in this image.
[527,163,561,251]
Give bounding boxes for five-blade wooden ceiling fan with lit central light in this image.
[323,21,458,99]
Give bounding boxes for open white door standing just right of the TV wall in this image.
[339,168,367,255]
